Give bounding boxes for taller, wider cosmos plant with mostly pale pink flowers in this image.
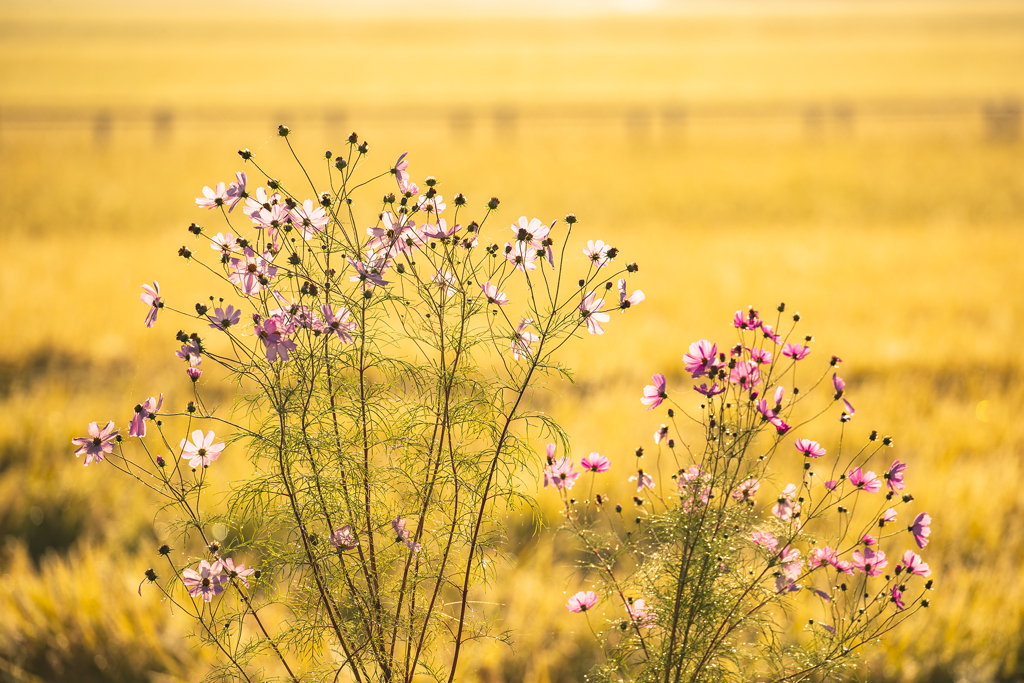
[74,127,643,681]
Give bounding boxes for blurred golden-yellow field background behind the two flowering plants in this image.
[0,0,1024,683]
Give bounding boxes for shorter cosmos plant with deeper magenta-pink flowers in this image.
[546,305,932,683]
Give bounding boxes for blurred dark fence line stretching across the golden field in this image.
[0,98,1024,143]
